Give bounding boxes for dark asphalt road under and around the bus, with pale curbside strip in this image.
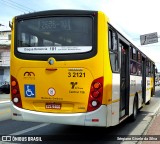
[0,87,160,144]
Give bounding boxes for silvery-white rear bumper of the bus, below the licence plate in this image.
[11,102,107,127]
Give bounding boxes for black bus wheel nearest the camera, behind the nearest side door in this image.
[130,96,138,121]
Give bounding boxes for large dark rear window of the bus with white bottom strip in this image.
[16,16,93,55]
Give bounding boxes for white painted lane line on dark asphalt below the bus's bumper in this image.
[10,123,49,135]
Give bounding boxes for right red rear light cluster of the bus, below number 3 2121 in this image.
[87,77,103,112]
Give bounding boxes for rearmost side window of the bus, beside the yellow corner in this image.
[109,30,119,72]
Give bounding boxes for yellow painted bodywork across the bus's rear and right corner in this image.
[10,12,112,113]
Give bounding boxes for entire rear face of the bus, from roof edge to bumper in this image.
[11,10,106,126]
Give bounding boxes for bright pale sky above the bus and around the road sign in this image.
[0,0,160,71]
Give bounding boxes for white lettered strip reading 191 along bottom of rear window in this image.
[18,46,92,54]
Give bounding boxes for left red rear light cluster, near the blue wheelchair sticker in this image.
[11,76,22,108]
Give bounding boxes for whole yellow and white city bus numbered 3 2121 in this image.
[10,10,155,127]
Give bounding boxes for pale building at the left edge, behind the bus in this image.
[0,30,11,85]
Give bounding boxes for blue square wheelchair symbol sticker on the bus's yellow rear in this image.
[24,85,35,97]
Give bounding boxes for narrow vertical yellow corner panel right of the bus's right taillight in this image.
[101,14,112,127]
